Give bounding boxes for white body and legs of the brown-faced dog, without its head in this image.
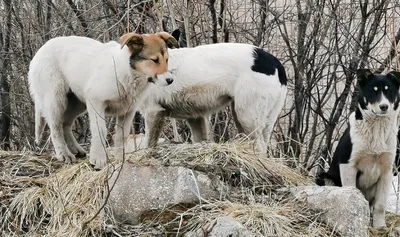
[28,36,167,168]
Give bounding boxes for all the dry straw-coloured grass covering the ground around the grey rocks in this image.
[0,141,398,236]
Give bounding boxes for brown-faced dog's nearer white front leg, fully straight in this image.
[86,101,107,169]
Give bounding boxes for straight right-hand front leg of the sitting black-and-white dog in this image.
[372,153,394,228]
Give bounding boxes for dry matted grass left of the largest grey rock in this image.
[0,153,118,236]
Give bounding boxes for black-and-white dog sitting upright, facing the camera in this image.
[316,69,400,227]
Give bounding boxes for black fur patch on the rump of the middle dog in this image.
[251,47,287,85]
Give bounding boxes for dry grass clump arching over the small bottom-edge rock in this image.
[138,199,337,237]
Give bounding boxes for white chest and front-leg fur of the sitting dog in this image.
[346,103,399,227]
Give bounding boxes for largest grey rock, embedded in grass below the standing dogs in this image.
[108,163,219,224]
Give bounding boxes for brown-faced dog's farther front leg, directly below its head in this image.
[115,110,135,155]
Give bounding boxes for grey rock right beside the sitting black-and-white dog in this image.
[290,186,370,237]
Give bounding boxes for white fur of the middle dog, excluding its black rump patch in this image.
[141,43,287,152]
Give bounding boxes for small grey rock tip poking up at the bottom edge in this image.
[185,216,255,237]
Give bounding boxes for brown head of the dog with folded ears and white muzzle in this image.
[120,32,178,86]
